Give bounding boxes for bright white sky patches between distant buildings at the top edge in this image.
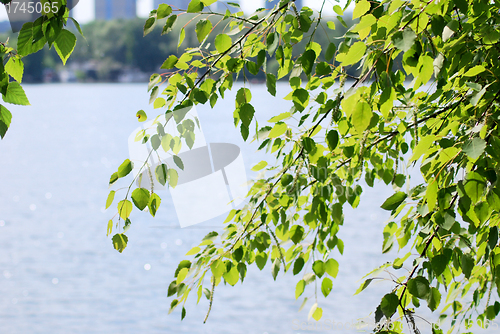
[0,0,344,23]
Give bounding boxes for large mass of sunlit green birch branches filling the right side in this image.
[108,0,500,332]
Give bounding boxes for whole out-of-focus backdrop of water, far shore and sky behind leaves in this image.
[0,0,496,334]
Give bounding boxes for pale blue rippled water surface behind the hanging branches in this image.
[0,84,484,334]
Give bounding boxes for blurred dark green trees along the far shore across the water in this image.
[0,14,368,83]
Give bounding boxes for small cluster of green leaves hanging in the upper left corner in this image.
[0,0,81,139]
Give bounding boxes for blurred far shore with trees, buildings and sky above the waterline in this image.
[0,0,362,83]
